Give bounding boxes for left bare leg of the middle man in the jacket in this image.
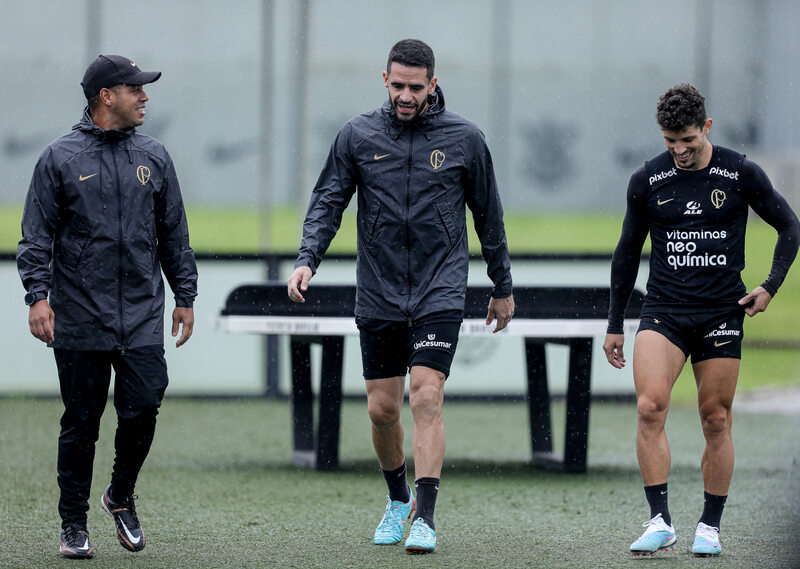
[366,376,406,470]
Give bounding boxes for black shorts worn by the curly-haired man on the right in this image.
[639,309,744,363]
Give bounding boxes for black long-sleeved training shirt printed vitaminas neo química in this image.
[608,146,800,334]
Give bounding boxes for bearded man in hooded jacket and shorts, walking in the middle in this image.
[287,40,514,553]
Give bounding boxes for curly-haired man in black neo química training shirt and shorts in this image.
[603,83,800,557]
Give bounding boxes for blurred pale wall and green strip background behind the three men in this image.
[0,0,800,394]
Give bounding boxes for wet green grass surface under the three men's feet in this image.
[0,396,800,569]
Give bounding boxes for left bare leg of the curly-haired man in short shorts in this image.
[633,330,686,486]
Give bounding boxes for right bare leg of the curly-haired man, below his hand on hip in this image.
[692,358,740,496]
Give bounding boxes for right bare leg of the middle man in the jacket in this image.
[409,366,445,479]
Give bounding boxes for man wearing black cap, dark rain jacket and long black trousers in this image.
[17,55,197,559]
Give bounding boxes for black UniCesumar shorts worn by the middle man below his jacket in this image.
[356,310,463,379]
